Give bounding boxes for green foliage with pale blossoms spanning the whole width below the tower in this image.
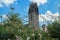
[0,13,60,40]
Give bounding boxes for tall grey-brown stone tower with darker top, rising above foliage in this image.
[28,2,39,30]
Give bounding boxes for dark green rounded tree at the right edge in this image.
[48,22,60,40]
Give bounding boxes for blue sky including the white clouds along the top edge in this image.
[0,0,60,25]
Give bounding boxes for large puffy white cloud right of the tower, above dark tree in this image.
[39,11,58,23]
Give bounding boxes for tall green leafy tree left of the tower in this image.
[0,13,23,40]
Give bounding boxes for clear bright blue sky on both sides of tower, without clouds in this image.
[0,0,60,15]
